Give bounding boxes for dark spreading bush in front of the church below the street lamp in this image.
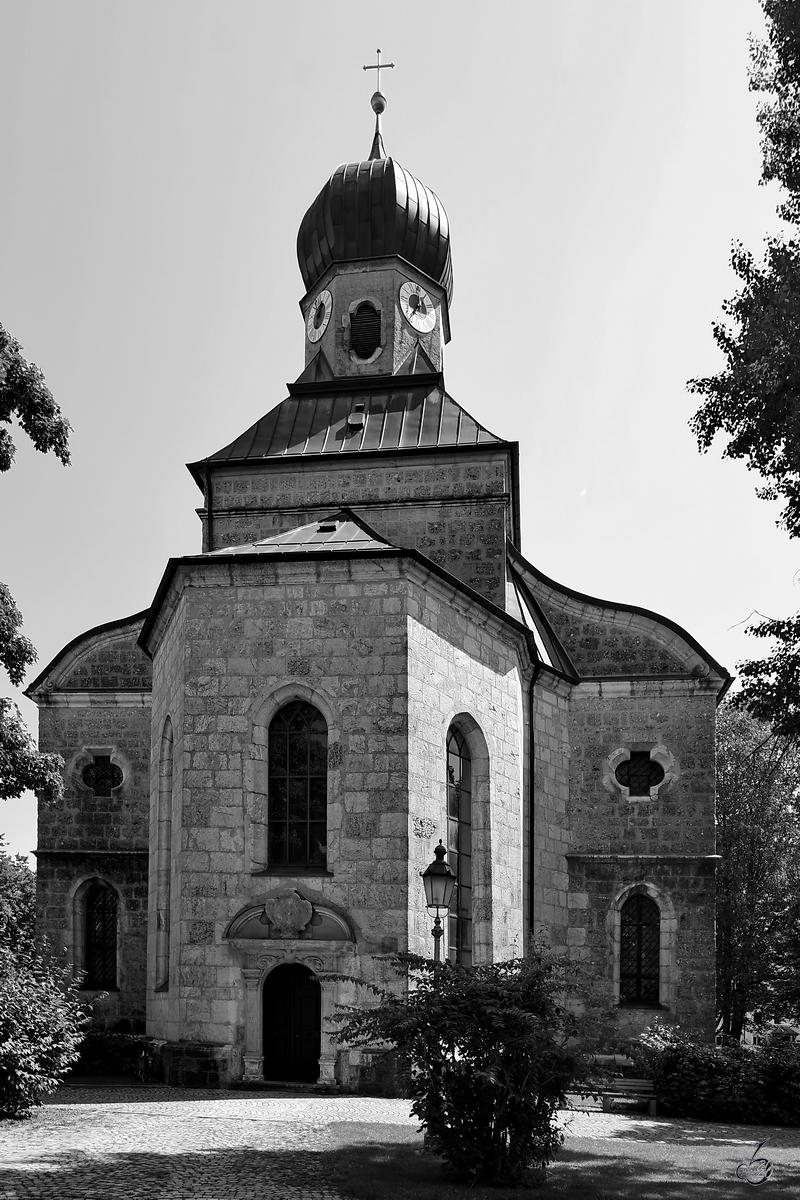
[337,949,587,1184]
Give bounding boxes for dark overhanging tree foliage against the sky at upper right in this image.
[688,0,800,738]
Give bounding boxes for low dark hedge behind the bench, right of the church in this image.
[630,1025,800,1126]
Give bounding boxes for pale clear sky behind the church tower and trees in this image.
[0,0,800,853]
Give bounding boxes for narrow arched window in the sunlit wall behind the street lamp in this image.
[447,728,473,967]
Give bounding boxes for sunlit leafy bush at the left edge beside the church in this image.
[0,947,88,1117]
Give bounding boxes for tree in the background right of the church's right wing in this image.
[716,703,800,1038]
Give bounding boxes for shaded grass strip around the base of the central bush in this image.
[325,1122,800,1200]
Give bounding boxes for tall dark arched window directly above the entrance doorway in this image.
[267,700,327,866]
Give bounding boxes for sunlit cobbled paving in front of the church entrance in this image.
[0,1087,800,1200]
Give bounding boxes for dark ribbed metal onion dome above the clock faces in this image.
[297,147,452,302]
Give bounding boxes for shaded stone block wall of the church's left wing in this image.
[29,616,151,1030]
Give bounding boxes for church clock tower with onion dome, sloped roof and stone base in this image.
[190,79,519,607]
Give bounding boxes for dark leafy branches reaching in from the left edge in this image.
[0,325,70,800]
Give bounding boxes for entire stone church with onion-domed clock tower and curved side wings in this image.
[26,91,730,1086]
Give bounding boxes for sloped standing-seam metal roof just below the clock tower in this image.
[204,383,500,463]
